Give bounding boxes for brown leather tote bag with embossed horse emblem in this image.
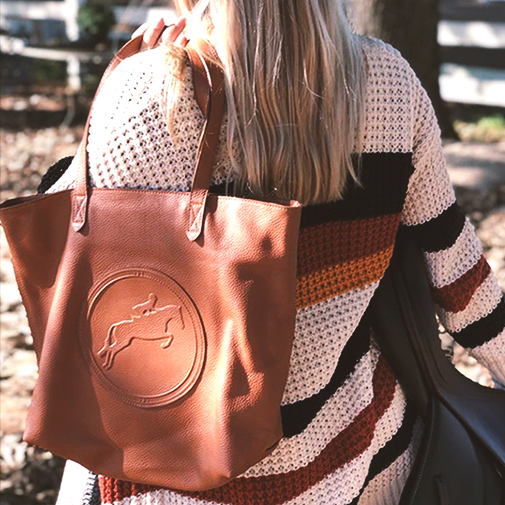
[0,38,301,490]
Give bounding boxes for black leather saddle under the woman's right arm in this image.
[370,230,505,505]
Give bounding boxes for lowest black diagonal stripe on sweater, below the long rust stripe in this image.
[348,404,418,505]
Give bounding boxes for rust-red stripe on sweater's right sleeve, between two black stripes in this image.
[432,255,491,312]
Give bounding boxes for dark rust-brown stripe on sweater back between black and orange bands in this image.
[297,214,400,276]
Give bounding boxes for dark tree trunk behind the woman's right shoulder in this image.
[349,0,458,138]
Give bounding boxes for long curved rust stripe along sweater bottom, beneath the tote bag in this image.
[100,356,396,505]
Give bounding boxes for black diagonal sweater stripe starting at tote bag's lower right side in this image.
[281,316,370,438]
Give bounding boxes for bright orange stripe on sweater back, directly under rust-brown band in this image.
[296,245,394,310]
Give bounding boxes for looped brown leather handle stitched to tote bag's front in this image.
[72,36,225,240]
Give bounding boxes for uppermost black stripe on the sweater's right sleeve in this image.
[412,202,465,252]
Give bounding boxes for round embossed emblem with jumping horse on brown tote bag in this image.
[80,269,206,407]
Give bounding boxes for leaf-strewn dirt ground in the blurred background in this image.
[0,127,505,505]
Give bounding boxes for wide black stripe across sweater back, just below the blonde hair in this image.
[300,153,413,228]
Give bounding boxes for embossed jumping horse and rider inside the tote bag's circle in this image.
[97,293,184,370]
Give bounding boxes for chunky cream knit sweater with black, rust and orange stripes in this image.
[51,38,505,505]
